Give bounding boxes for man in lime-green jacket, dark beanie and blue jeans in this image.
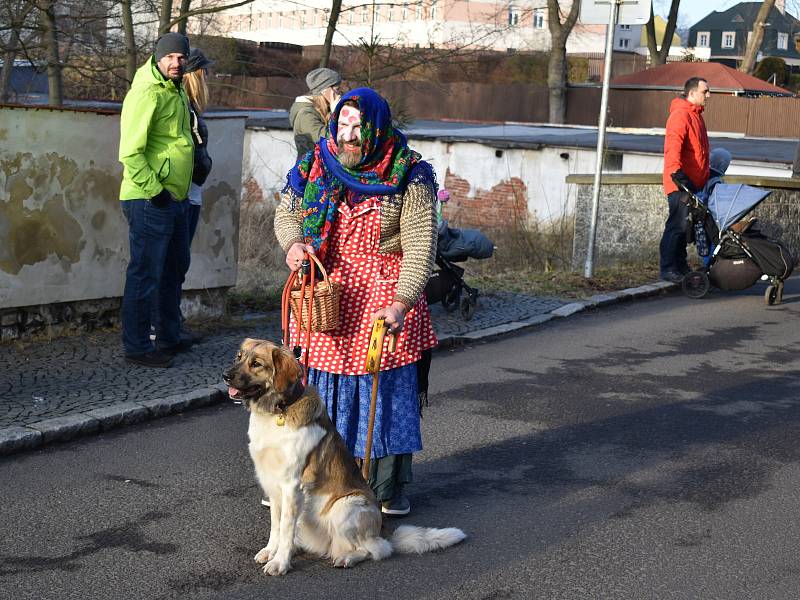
[119,33,194,367]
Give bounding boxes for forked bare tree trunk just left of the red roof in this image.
[547,0,581,123]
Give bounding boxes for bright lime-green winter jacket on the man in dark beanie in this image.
[119,56,194,200]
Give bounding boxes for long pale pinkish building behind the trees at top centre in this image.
[198,0,633,54]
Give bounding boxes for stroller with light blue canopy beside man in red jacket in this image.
[675,181,795,306]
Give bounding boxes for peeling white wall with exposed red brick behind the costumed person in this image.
[243,128,790,233]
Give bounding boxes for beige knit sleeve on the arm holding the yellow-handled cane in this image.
[394,183,436,307]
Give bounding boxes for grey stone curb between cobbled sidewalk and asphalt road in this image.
[0,281,678,456]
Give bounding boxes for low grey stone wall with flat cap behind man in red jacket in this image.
[567,175,800,270]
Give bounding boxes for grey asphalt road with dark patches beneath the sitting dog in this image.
[0,280,800,600]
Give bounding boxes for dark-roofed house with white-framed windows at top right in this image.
[687,0,800,67]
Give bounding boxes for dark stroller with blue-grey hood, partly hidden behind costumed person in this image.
[425,219,494,321]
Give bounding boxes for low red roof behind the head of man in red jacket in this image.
[611,62,794,96]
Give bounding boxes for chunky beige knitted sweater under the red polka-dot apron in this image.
[275,183,436,308]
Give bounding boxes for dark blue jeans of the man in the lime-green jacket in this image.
[121,200,189,354]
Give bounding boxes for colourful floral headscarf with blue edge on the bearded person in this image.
[286,88,435,255]
